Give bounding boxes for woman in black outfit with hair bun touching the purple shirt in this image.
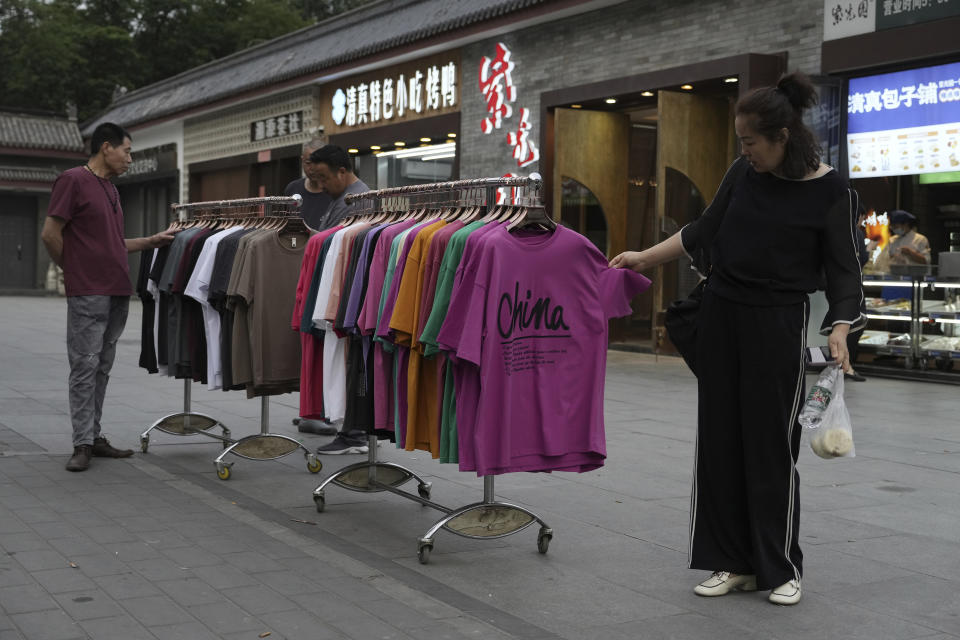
[610,74,866,605]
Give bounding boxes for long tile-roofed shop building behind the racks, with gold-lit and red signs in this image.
[79,0,856,351]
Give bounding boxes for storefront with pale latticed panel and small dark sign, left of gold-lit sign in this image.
[183,87,322,202]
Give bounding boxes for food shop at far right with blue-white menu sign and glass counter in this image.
[822,2,960,380]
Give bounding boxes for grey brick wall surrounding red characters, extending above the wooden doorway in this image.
[460,0,823,178]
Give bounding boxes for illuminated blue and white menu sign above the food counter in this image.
[847,63,960,178]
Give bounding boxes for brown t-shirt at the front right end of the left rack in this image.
[234,231,309,393]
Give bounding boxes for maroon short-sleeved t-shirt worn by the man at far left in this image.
[47,167,133,296]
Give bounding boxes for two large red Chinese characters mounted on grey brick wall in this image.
[479,42,540,167]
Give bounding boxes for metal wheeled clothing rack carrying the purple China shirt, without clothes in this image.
[313,173,555,564]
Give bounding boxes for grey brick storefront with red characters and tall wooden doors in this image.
[461,2,820,353]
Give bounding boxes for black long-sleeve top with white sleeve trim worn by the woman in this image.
[680,157,865,333]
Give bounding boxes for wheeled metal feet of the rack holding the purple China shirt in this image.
[313,436,553,564]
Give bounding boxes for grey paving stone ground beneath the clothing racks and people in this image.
[0,297,960,640]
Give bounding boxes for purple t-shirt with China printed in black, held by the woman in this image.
[438,226,650,475]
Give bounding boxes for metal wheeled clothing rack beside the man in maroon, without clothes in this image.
[140,195,323,480]
